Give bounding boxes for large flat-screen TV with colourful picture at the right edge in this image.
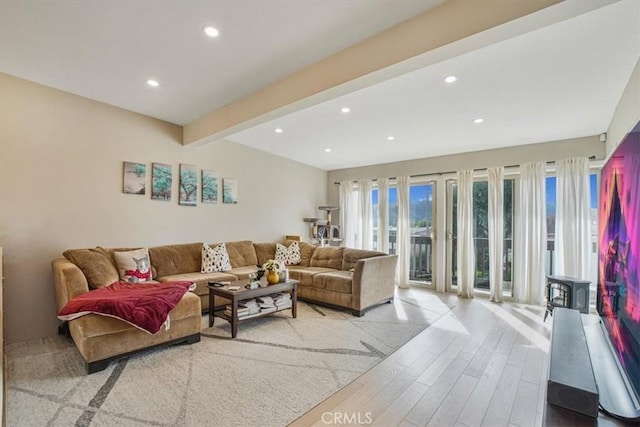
[597,123,640,401]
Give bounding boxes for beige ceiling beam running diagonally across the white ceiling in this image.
[183,0,564,145]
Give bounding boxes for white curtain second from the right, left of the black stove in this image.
[513,162,547,305]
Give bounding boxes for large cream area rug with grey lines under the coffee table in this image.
[7,298,452,426]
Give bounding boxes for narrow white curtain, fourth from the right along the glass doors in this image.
[457,170,476,298]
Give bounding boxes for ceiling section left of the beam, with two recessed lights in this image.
[0,0,440,125]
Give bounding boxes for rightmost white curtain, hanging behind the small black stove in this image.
[554,157,591,280]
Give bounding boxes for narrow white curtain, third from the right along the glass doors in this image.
[487,167,504,302]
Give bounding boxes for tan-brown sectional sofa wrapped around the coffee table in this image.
[52,240,397,373]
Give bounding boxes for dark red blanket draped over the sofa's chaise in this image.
[58,282,195,334]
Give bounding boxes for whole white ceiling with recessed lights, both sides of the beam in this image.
[0,0,640,170]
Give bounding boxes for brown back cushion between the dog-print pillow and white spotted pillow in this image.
[149,243,202,277]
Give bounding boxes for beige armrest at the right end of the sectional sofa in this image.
[352,255,398,310]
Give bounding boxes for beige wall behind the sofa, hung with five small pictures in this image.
[0,74,327,342]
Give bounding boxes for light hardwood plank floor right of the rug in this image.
[291,288,615,427]
